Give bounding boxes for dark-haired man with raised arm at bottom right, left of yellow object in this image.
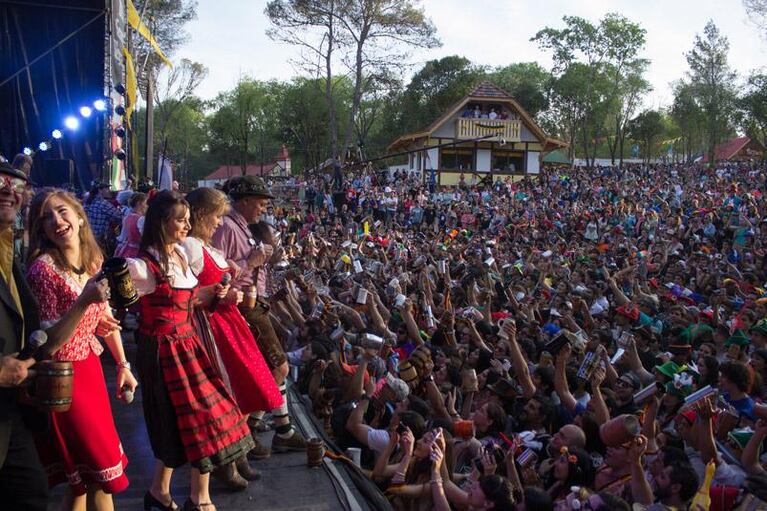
[627,436,698,511]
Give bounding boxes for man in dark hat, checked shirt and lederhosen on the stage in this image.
[212,176,306,459]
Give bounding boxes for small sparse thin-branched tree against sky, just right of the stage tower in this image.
[154,59,208,148]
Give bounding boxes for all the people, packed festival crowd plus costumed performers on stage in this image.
[0,155,767,511]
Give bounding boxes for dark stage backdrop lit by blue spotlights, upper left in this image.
[0,0,107,188]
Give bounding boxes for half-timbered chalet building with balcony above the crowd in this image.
[388,82,567,185]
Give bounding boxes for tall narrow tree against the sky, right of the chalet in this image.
[685,20,737,163]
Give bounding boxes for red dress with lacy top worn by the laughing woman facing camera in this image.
[27,255,128,495]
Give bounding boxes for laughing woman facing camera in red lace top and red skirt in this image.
[28,190,136,510]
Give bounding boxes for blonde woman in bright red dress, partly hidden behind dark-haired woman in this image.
[183,188,283,487]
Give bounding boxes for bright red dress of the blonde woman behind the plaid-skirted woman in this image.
[197,247,282,414]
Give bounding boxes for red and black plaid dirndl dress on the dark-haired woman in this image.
[136,256,254,473]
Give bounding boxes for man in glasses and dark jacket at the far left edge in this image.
[0,163,48,511]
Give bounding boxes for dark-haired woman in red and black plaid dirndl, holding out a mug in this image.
[128,191,254,511]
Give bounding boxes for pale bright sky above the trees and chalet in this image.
[172,0,767,108]
